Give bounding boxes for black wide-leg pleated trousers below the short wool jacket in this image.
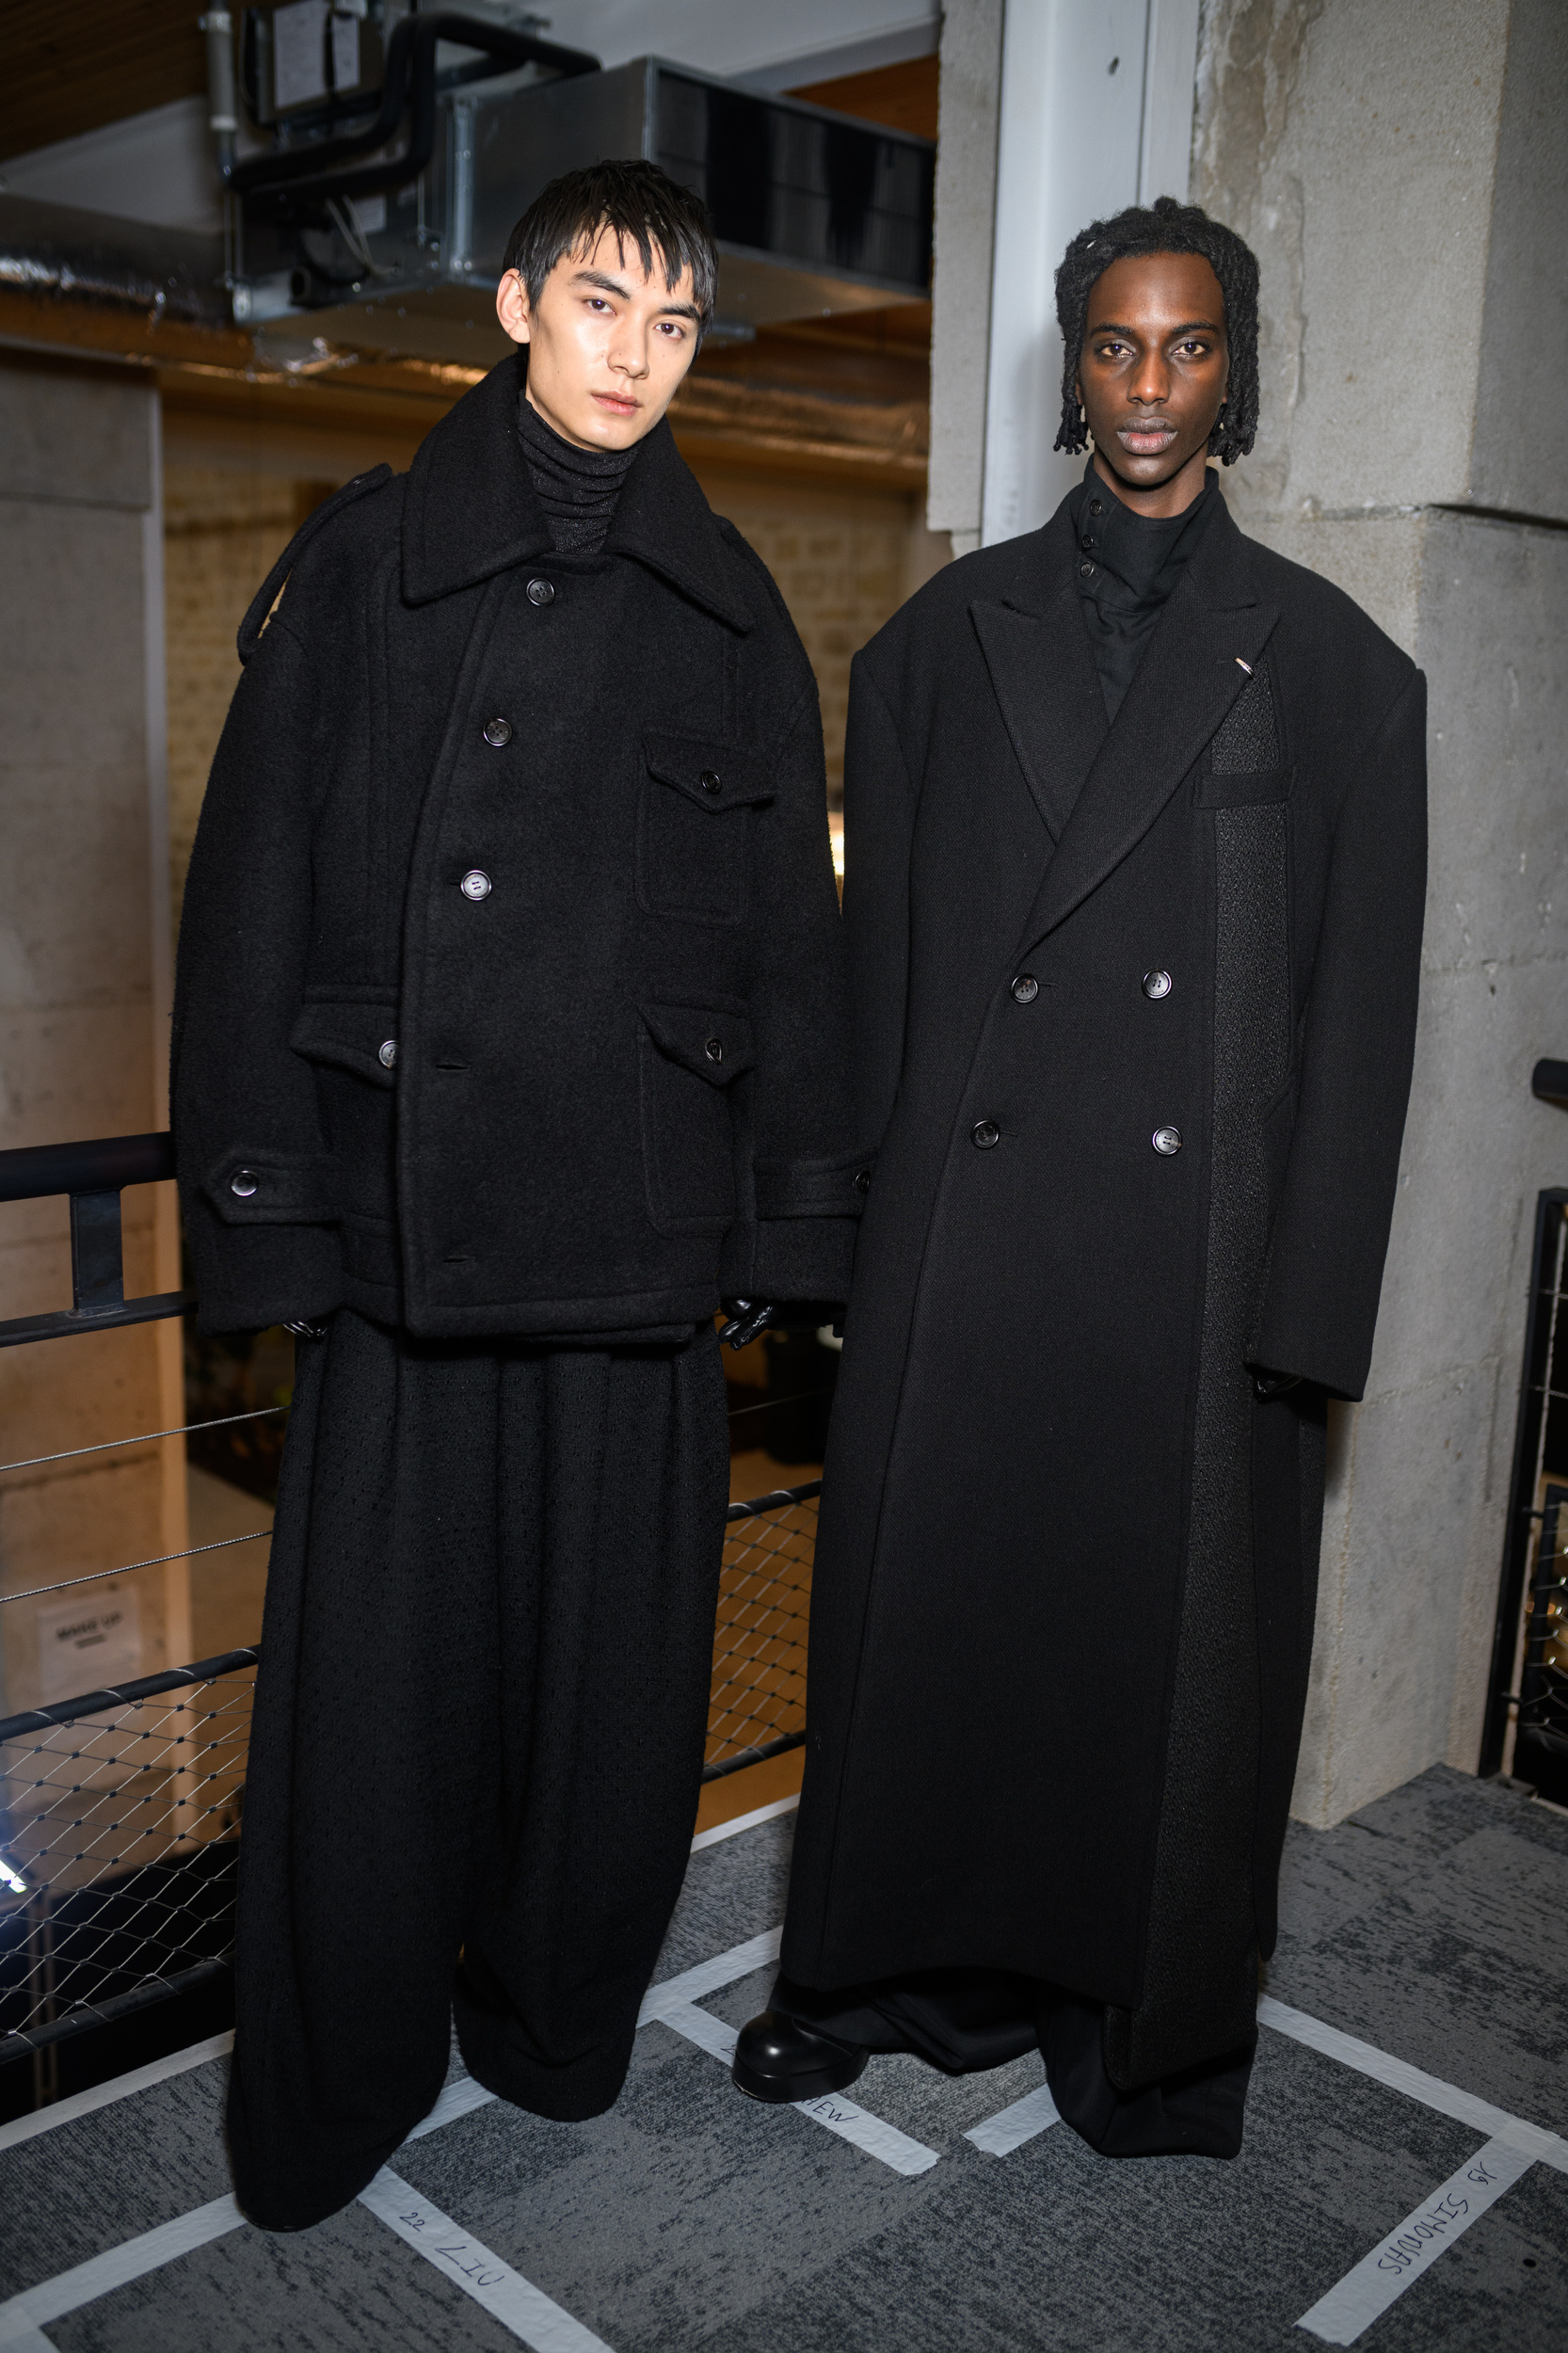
[229,1311,729,2231]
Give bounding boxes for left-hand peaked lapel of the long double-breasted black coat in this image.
[970,504,1107,842]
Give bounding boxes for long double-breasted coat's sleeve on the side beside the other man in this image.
[843,654,914,1151]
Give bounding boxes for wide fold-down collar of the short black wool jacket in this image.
[403,351,756,631]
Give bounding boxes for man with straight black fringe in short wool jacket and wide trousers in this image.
[174,163,862,2231]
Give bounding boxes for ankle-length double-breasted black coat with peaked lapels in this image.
[784,477,1424,2089]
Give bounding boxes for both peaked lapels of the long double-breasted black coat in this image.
[970,482,1278,949]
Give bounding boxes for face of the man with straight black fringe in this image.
[494,229,699,450]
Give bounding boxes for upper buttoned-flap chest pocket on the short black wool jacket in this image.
[638,734,772,922]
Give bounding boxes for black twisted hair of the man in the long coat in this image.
[1055,196,1257,466]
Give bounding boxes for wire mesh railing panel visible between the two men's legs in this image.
[704,1490,817,1782]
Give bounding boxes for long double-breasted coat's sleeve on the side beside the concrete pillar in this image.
[1248,671,1427,1398]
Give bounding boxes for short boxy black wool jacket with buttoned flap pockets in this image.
[172,358,862,1339]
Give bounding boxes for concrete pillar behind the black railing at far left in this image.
[0,351,191,1711]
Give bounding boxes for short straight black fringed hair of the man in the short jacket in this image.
[502,158,718,334]
